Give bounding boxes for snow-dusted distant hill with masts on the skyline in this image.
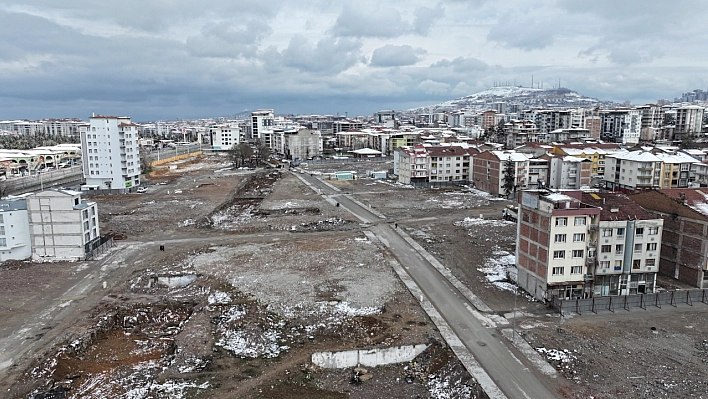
[409,86,615,113]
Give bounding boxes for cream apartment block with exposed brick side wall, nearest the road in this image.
[516,190,601,301]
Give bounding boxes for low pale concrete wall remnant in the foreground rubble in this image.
[312,344,428,369]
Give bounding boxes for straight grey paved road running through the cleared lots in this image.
[301,175,556,399]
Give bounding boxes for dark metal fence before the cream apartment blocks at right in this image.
[551,288,708,315]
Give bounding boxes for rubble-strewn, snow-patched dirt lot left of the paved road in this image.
[0,158,478,398]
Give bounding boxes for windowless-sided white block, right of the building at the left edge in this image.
[27,190,100,260]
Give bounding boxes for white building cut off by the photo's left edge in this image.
[0,199,32,262]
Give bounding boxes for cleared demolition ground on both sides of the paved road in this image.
[0,157,708,398]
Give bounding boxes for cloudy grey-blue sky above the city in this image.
[0,0,708,121]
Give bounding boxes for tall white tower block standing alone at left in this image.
[81,116,141,193]
